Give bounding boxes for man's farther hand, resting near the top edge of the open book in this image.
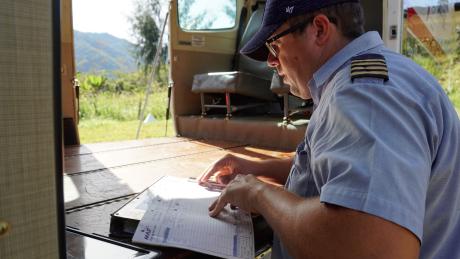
[198,154,248,188]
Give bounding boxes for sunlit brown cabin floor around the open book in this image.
[64,137,292,258]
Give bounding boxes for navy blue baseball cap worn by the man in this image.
[240,0,359,61]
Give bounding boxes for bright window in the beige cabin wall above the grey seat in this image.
[178,0,236,31]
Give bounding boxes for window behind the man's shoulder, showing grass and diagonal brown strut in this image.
[402,0,460,111]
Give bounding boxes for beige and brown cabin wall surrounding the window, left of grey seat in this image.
[169,0,244,135]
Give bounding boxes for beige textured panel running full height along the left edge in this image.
[0,0,64,258]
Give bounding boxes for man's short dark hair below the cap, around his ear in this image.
[288,3,364,40]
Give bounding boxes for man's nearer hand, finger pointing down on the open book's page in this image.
[209,174,266,217]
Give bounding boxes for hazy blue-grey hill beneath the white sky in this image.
[74,31,137,75]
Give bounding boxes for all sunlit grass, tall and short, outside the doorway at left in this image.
[78,88,175,144]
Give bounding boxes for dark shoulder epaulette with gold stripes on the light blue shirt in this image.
[351,54,388,81]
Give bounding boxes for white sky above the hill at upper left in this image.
[72,0,135,42]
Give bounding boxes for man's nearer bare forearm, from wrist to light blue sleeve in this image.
[252,183,419,259]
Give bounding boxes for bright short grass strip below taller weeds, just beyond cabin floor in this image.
[78,118,176,144]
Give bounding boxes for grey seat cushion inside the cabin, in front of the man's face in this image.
[192,71,275,100]
